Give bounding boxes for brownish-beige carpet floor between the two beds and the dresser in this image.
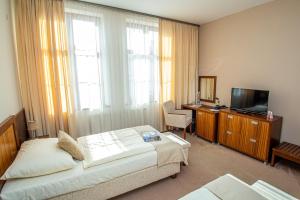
[114,135,300,200]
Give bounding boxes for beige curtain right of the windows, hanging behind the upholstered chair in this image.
[160,19,199,128]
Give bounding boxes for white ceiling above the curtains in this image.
[83,0,272,24]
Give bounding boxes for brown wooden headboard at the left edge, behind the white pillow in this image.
[0,109,28,191]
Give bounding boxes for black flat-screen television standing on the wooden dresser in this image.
[230,88,269,115]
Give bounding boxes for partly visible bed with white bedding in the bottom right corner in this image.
[180,174,297,200]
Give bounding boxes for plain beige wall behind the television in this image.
[199,0,300,145]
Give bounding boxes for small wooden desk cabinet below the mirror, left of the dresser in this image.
[196,106,218,142]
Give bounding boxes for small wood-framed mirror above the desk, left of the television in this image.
[198,76,217,103]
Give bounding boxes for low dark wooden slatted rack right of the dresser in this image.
[271,142,300,166]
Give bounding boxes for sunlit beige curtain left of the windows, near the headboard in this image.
[14,0,72,136]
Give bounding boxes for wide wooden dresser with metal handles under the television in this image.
[218,109,282,162]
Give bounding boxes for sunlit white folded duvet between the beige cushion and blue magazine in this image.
[77,128,155,168]
